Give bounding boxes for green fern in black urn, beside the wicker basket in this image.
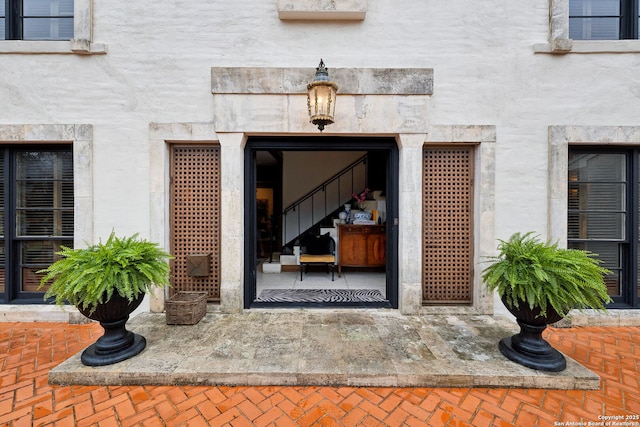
[39,232,171,366]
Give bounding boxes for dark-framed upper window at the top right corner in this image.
[569,0,640,40]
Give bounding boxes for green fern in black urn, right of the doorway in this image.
[482,232,611,372]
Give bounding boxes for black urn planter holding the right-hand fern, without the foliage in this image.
[499,297,567,372]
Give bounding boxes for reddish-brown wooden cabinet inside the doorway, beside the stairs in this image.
[338,224,387,277]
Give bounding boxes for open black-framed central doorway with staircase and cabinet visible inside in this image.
[244,136,398,308]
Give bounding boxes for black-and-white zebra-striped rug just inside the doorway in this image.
[256,289,387,303]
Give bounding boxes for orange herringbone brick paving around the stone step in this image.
[0,323,640,427]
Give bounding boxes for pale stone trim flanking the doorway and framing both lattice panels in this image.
[149,123,496,314]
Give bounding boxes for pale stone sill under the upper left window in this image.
[0,39,107,55]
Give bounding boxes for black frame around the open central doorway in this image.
[244,135,400,309]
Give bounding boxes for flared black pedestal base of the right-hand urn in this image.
[499,320,567,372]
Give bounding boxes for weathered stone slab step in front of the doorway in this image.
[49,309,600,389]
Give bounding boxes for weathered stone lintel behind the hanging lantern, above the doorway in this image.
[211,67,433,134]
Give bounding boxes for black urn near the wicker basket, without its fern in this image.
[78,291,147,366]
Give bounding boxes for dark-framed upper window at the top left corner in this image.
[0,0,73,40]
